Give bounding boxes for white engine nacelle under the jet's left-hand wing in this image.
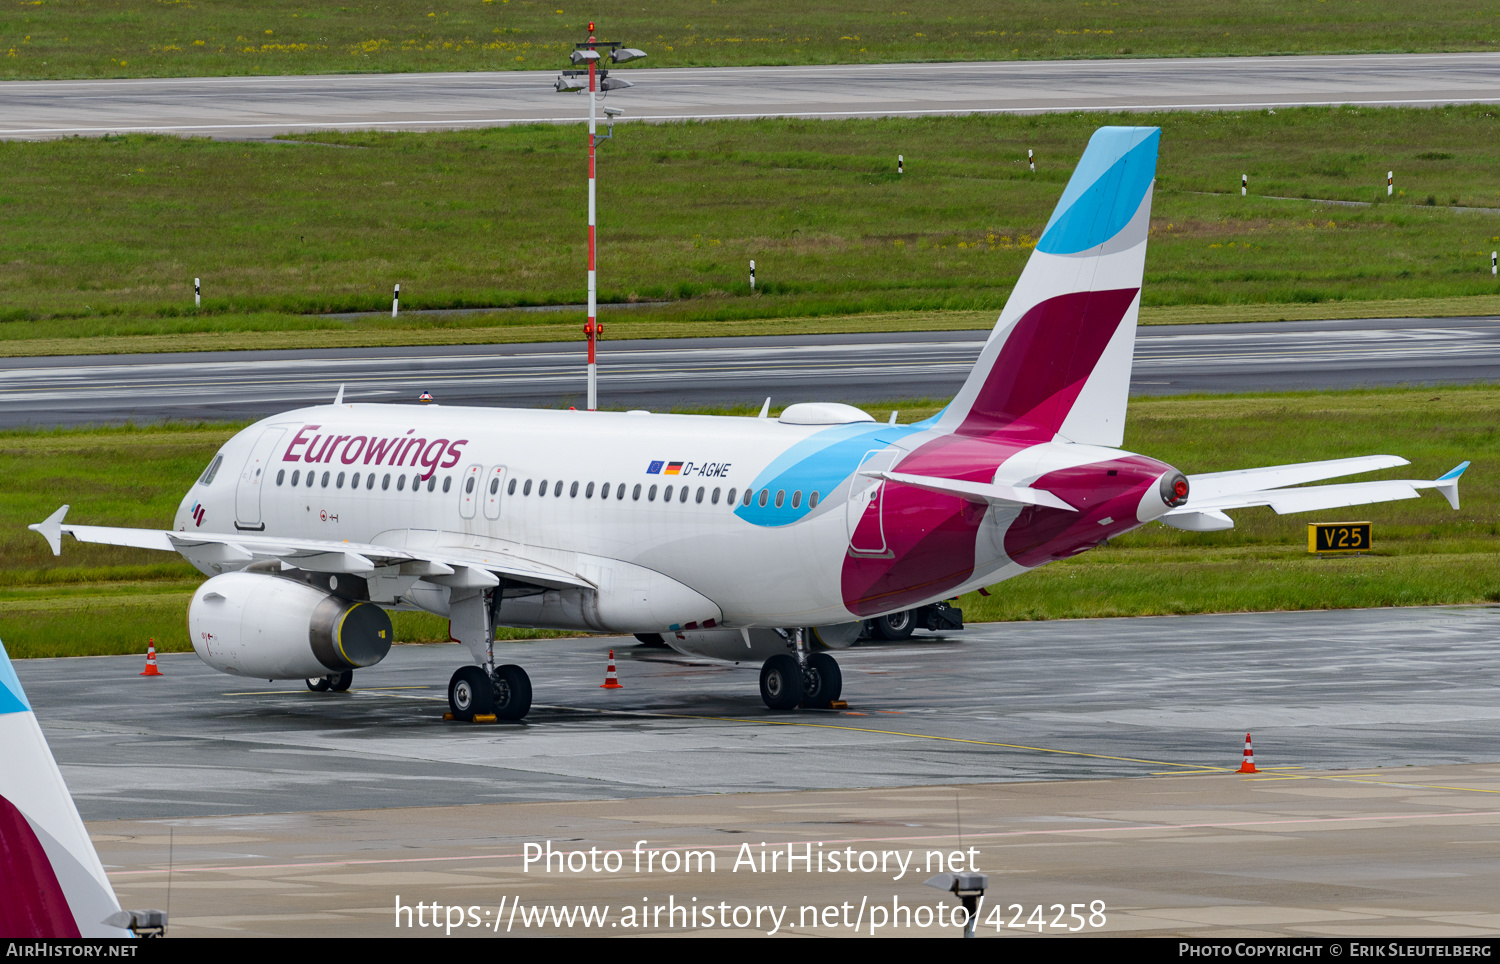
[188,573,395,679]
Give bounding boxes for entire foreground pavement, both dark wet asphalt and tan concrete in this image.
[29,607,1500,940]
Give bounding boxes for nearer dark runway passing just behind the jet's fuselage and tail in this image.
[0,318,1500,427]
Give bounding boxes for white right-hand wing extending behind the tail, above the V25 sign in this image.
[1161,456,1469,532]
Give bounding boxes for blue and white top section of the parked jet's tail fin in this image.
[1037,127,1161,255]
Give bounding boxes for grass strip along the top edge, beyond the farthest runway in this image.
[0,0,1500,78]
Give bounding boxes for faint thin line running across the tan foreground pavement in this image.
[110,809,1500,877]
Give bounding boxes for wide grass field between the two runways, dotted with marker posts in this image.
[0,106,1500,354]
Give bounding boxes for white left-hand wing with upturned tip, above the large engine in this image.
[29,505,594,589]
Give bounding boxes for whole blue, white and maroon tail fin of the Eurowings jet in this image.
[936,127,1161,447]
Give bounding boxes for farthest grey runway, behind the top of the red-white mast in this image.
[0,54,1500,138]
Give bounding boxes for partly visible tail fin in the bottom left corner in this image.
[0,643,131,937]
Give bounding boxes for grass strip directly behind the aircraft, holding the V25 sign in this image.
[0,388,1500,657]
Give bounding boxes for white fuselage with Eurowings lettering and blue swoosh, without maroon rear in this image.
[174,405,1170,631]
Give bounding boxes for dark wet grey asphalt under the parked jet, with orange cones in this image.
[15,607,1500,820]
